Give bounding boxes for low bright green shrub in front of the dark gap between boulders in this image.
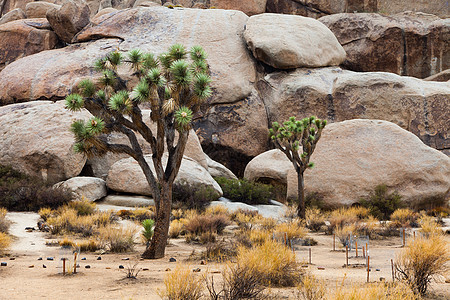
[215,177,276,204]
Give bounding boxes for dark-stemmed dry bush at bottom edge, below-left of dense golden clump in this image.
[204,264,265,300]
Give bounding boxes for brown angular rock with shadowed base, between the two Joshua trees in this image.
[194,91,269,176]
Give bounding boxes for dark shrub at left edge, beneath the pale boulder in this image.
[0,166,71,211]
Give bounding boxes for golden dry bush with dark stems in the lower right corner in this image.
[394,235,450,295]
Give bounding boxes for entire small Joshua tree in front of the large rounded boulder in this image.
[269,116,327,219]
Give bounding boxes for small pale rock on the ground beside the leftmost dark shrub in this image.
[54,176,107,202]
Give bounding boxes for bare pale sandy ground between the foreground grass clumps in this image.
[0,213,450,299]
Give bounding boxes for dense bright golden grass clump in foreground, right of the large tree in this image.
[236,240,301,286]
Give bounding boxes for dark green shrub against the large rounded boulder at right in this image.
[359,184,405,220]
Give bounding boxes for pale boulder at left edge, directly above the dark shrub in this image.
[0,101,89,183]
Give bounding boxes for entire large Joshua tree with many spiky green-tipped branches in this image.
[66,44,211,258]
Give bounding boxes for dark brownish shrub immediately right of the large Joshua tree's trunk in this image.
[172,183,218,210]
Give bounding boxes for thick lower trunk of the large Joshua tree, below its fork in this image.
[142,182,173,259]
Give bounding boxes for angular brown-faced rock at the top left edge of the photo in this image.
[47,0,91,43]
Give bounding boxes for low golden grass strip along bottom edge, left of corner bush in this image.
[327,283,418,300]
